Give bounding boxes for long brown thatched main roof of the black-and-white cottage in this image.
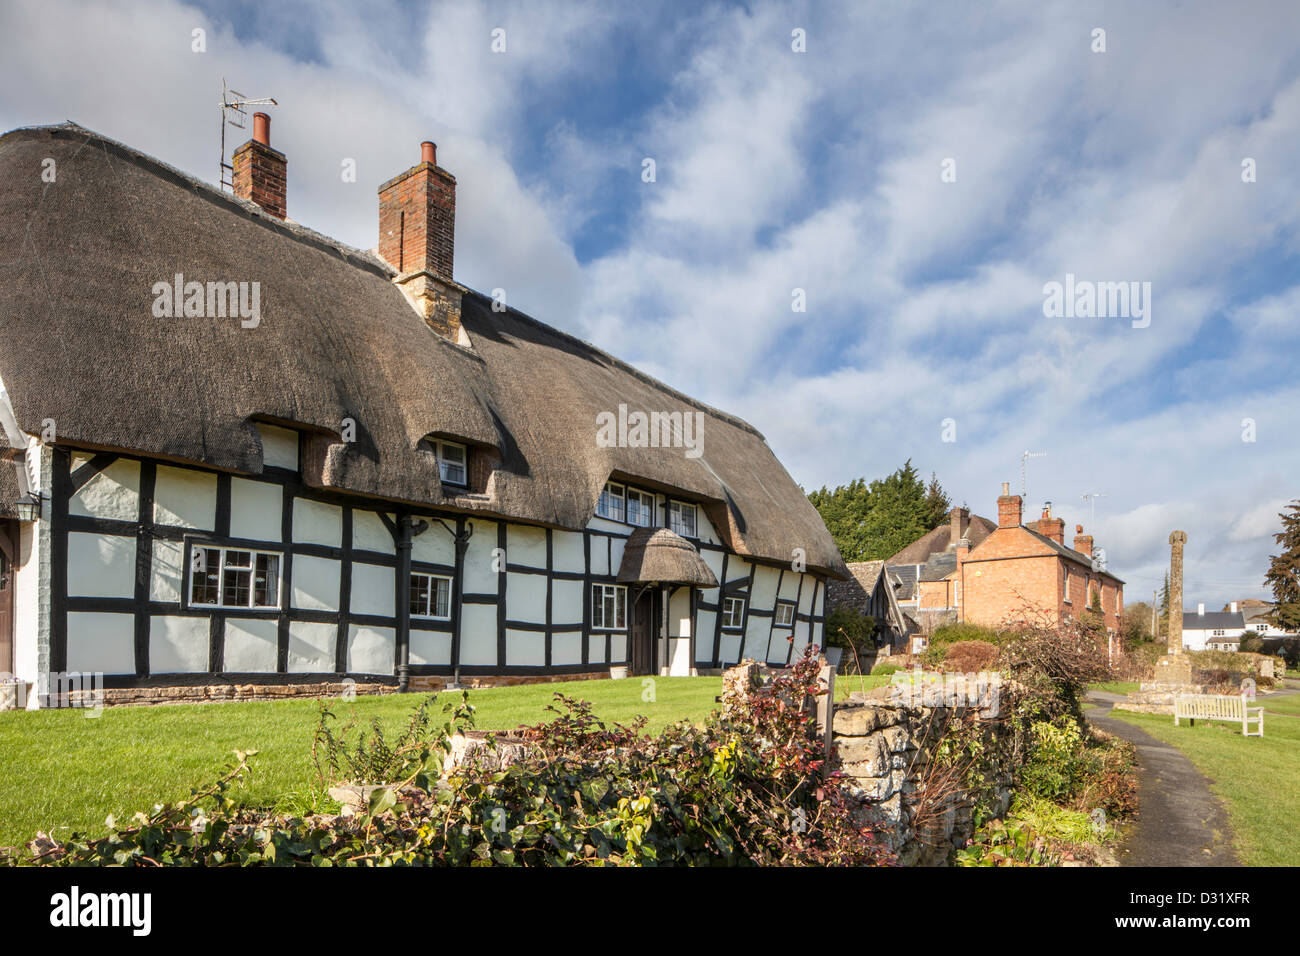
[0,124,845,575]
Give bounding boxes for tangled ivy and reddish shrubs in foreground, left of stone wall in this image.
[15,649,889,866]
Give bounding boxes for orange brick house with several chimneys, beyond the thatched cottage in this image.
[885,484,1123,633]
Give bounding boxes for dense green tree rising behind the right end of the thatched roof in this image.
[809,459,950,561]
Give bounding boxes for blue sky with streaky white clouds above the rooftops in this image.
[0,0,1300,607]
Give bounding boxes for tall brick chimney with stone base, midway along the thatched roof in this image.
[380,142,468,342]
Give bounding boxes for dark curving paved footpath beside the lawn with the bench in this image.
[1087,691,1242,866]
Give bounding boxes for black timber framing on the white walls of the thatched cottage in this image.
[49,446,823,687]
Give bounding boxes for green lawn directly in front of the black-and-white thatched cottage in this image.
[0,678,722,847]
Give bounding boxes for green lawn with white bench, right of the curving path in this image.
[1113,696,1300,866]
